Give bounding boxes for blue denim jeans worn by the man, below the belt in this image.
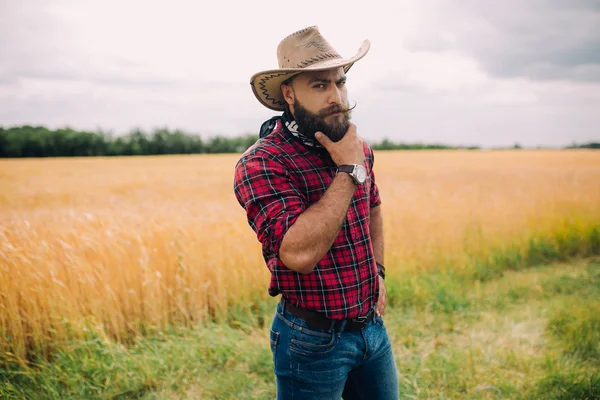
[270,303,399,400]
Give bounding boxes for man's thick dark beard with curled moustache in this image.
[294,100,352,142]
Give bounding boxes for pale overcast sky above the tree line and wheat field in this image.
[0,0,600,147]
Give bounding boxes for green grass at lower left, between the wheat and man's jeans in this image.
[0,325,273,399]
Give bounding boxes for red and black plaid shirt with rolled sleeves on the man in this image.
[234,120,381,319]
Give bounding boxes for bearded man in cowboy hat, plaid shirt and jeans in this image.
[234,26,398,400]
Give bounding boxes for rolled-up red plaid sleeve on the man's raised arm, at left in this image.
[234,157,307,255]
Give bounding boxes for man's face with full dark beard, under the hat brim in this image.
[282,67,351,142]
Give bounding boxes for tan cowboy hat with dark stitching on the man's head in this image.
[250,26,371,111]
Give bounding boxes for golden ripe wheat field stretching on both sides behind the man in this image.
[0,150,600,358]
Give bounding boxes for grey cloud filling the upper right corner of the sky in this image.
[406,0,600,81]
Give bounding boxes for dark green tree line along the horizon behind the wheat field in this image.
[0,125,600,158]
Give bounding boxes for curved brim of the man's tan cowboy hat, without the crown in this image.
[250,39,371,111]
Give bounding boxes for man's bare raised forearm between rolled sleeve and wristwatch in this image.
[279,173,356,274]
